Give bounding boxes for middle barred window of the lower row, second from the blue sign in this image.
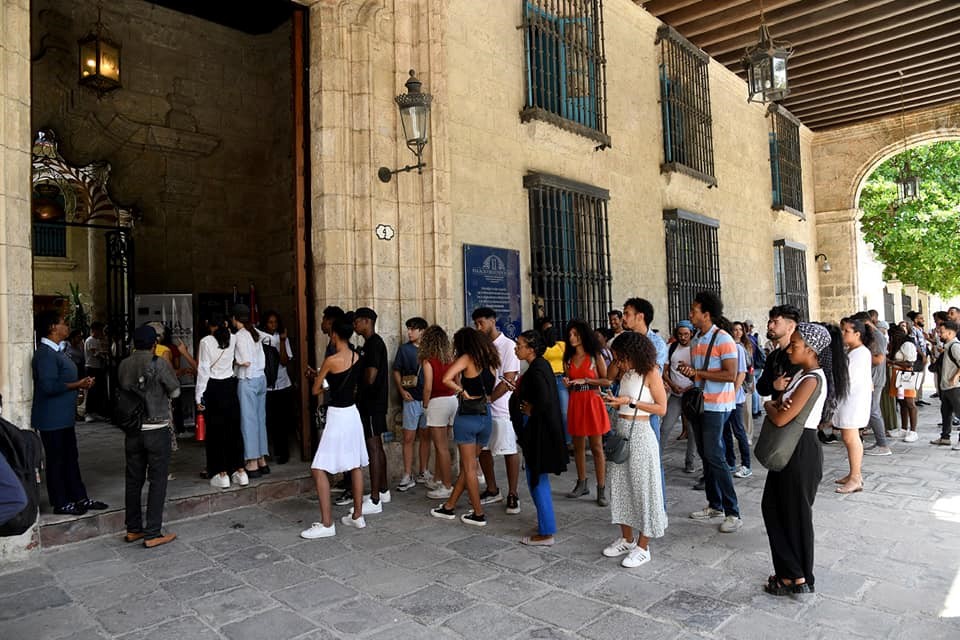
[663,209,720,327]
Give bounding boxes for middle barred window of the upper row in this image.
[656,25,717,186]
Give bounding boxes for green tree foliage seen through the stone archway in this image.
[859,141,960,296]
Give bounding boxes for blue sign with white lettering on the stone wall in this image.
[463,244,523,340]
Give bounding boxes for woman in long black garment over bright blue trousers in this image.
[510,331,568,546]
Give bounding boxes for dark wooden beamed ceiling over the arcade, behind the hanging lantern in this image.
[635,0,960,130]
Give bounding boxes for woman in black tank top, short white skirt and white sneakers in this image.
[300,313,370,540]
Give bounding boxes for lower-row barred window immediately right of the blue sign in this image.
[523,173,612,327]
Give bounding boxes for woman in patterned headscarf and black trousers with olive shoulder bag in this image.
[761,322,848,596]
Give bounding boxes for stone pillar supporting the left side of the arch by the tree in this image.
[816,209,860,322]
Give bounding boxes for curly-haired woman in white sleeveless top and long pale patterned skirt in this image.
[603,332,667,568]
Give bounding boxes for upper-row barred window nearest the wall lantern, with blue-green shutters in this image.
[520,0,610,146]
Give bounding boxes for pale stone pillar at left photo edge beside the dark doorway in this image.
[0,0,39,564]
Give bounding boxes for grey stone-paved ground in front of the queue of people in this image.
[0,404,960,640]
